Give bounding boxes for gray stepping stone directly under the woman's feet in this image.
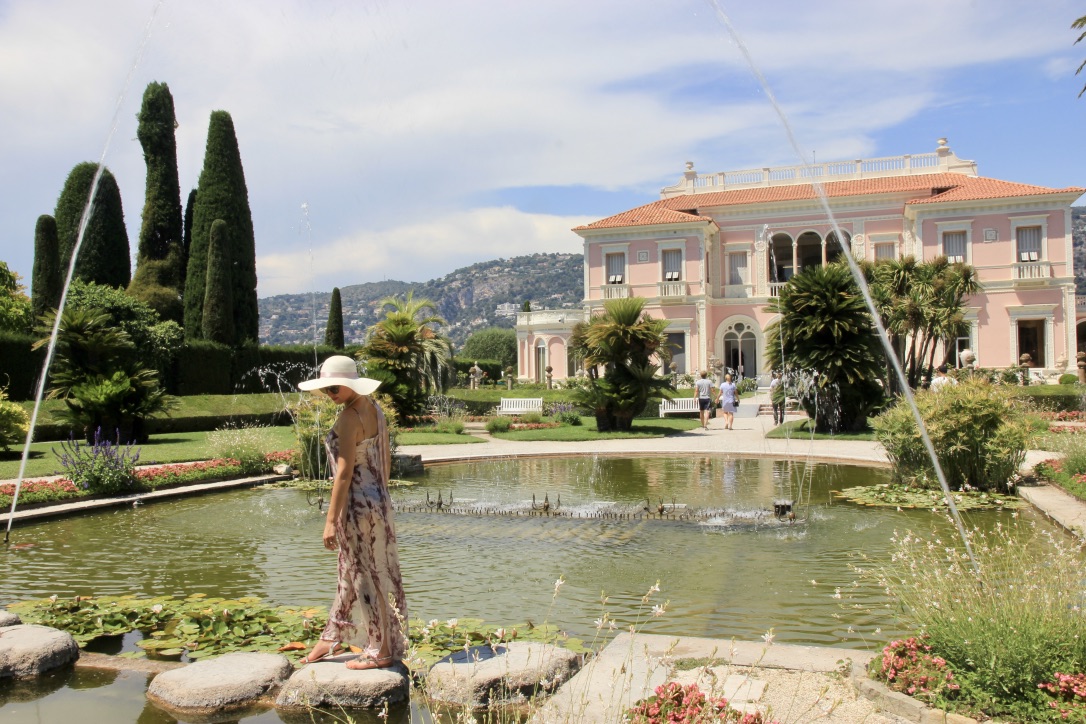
[275,657,409,709]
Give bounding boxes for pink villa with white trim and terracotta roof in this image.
[517,139,1086,382]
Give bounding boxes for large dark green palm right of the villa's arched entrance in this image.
[766,263,885,432]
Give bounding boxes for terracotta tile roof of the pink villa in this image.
[574,174,1086,231]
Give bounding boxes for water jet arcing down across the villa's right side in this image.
[706,0,981,573]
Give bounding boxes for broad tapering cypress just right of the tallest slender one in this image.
[185,111,260,343]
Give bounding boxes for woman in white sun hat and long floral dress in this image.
[298,355,407,670]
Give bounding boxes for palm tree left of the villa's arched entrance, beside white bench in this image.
[572,297,670,432]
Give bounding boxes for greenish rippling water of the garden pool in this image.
[0,456,1025,647]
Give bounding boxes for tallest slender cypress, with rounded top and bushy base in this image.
[128,82,184,321]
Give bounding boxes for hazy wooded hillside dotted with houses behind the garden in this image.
[260,254,584,348]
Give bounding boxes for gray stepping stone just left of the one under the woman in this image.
[147,653,294,714]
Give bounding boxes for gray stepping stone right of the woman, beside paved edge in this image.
[426,642,581,708]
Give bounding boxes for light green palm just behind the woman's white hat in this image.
[361,292,453,416]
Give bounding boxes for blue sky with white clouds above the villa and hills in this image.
[0,0,1086,296]
